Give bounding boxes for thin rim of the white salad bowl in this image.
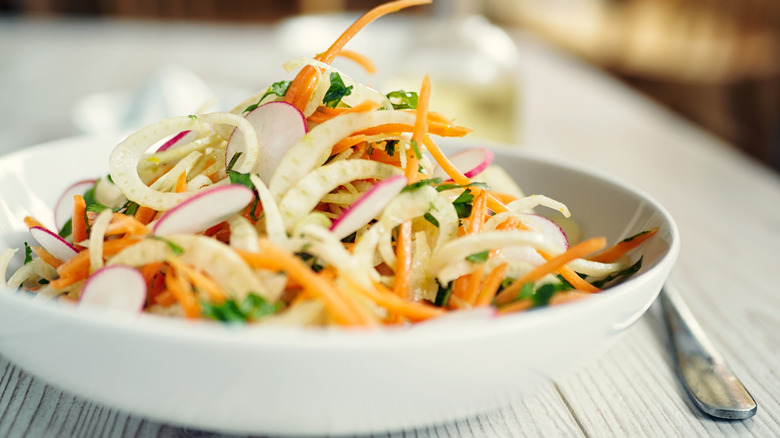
[0,135,680,350]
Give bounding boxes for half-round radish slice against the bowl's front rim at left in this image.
[79,265,146,312]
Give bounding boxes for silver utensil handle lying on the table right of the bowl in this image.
[660,283,758,420]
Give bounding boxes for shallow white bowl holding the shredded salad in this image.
[0,138,679,435]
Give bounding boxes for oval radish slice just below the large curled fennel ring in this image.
[152,184,255,235]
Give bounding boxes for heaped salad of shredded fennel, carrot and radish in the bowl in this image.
[0,0,657,327]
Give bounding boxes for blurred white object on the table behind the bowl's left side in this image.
[73,65,216,134]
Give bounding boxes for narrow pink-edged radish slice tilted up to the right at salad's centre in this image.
[330,175,408,239]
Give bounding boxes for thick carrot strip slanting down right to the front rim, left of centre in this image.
[241,239,372,325]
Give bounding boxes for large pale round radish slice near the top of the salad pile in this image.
[225,102,306,184]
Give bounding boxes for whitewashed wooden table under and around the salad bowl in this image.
[0,15,780,437]
